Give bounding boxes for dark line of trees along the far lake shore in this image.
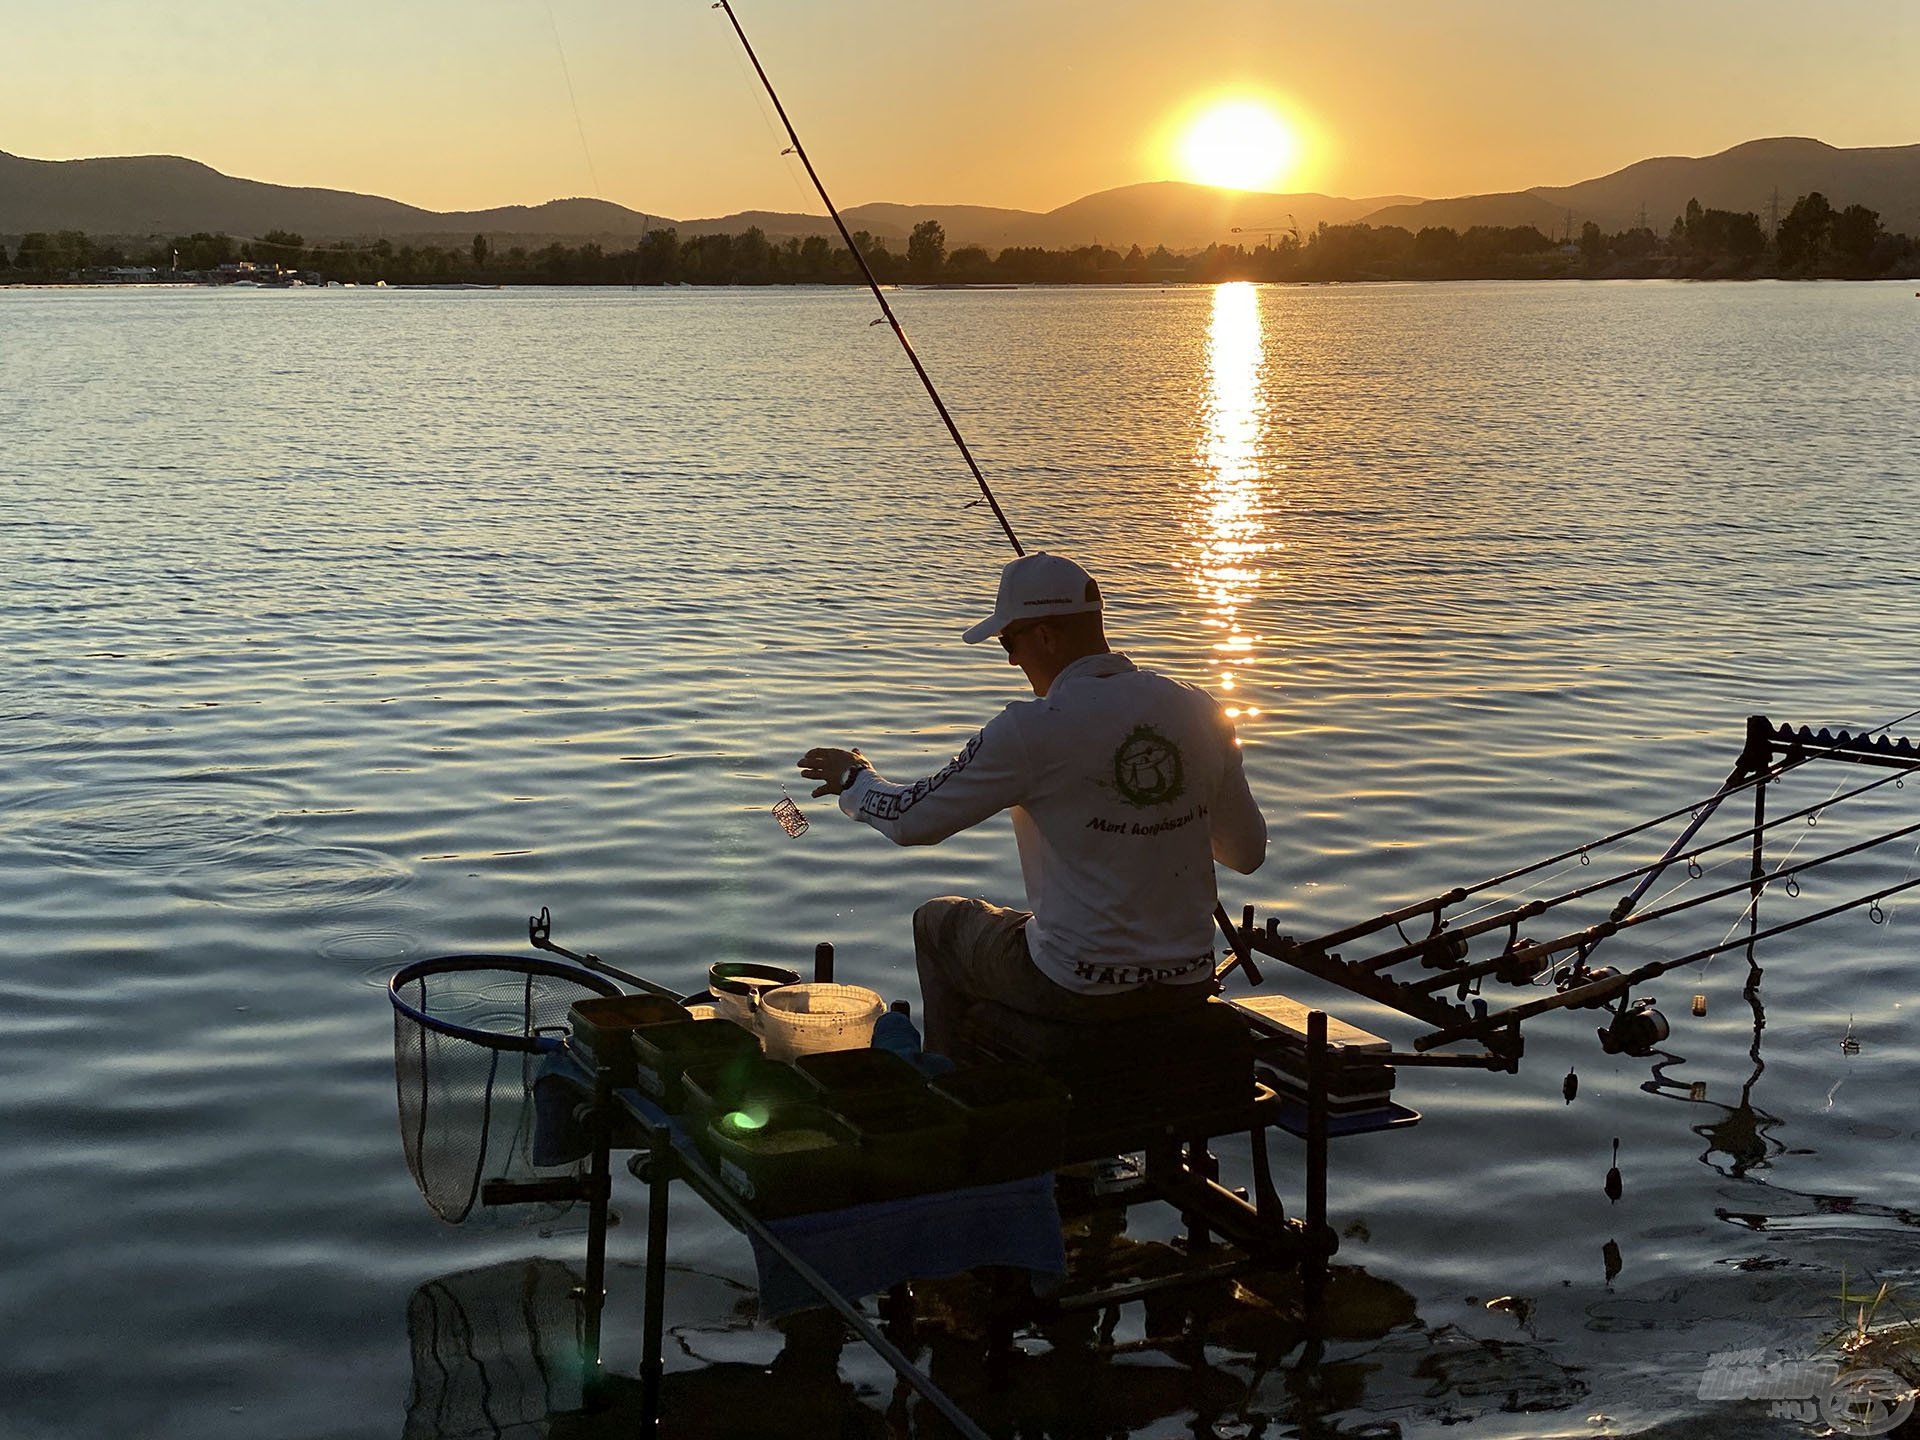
[0,192,1920,284]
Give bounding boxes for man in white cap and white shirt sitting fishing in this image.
[799,551,1267,1054]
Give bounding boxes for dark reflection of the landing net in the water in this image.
[403,1260,586,1440]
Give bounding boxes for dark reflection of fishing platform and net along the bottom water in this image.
[403,1215,1586,1440]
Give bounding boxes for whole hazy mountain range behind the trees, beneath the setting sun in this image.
[0,138,1920,250]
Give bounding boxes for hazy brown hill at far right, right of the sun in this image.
[1365,136,1920,234]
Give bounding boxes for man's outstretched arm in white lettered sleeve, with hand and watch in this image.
[801,714,1027,845]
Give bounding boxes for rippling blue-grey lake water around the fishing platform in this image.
[0,284,1920,1440]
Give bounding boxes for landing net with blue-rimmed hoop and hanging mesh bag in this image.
[392,956,618,1225]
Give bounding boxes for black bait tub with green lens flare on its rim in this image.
[699,1104,862,1219]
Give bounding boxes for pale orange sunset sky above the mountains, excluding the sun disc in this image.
[0,0,1920,219]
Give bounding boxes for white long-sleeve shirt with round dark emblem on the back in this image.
[839,653,1267,995]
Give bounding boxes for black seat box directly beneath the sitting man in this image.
[952,1000,1254,1164]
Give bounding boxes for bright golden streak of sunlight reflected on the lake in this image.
[1187,282,1277,720]
